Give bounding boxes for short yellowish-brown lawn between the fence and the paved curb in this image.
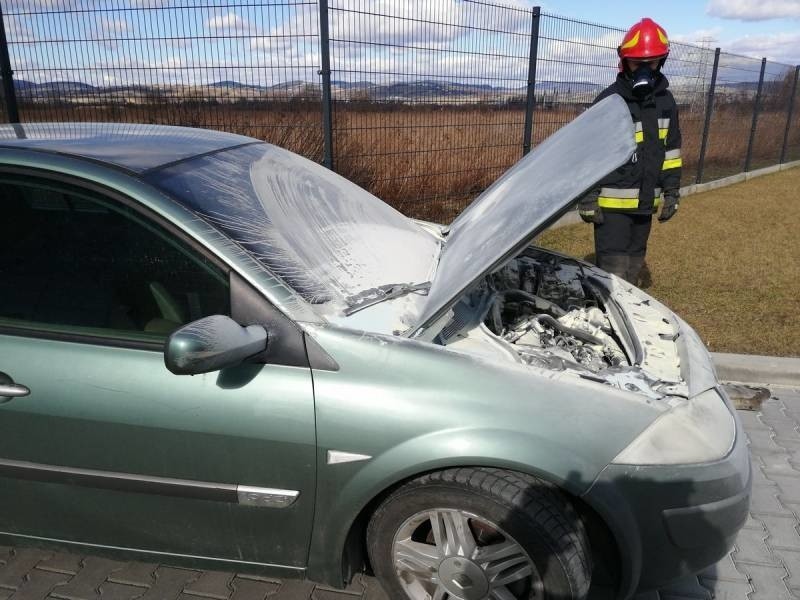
[537,168,800,356]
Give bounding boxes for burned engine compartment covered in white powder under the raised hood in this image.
[433,246,688,399]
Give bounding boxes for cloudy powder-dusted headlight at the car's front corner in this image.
[612,389,736,465]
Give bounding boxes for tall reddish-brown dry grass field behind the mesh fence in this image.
[21,102,800,222]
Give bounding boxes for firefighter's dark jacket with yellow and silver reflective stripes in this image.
[591,73,682,214]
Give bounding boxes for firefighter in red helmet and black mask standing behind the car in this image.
[578,18,681,284]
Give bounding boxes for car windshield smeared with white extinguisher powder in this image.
[147,144,439,310]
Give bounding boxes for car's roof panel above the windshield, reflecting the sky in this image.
[0,123,259,173]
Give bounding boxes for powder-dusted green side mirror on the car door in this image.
[164,315,267,375]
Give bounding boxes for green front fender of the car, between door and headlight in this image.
[308,327,660,584]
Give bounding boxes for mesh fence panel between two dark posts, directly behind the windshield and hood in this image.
[329,0,531,218]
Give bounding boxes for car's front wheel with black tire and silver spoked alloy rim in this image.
[367,467,592,600]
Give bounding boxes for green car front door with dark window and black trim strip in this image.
[0,173,315,568]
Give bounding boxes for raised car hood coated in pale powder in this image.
[407,95,636,337]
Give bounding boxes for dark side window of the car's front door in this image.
[0,177,230,341]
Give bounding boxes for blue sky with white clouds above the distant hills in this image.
[3,0,800,89]
